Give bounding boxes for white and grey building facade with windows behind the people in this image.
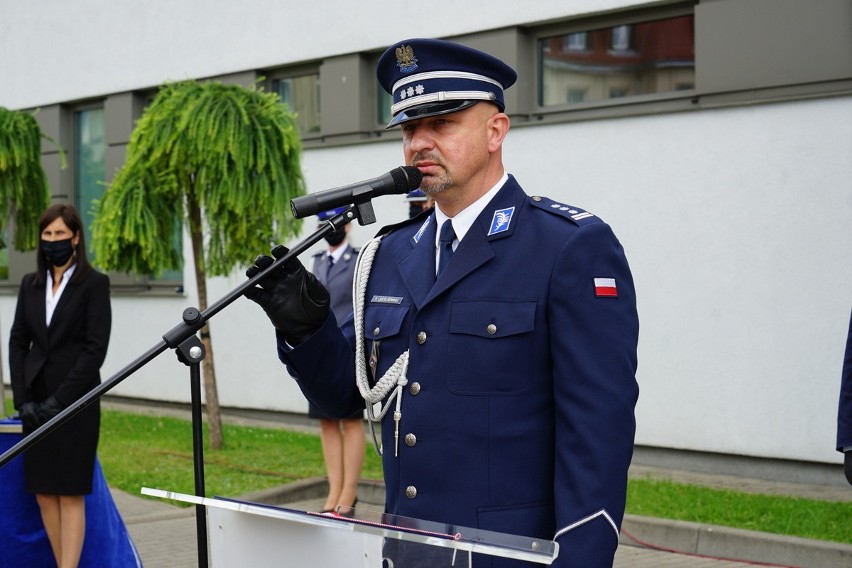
[0,0,852,463]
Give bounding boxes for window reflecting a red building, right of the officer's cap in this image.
[538,15,695,107]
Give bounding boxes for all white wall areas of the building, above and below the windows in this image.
[0,0,852,463]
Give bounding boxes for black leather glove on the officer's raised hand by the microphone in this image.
[245,245,330,345]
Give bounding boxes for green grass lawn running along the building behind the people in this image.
[6,400,852,544]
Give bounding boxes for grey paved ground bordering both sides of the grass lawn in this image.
[101,402,852,568]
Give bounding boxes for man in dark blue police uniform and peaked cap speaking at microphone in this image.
[246,39,638,568]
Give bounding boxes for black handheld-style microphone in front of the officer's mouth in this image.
[290,166,423,219]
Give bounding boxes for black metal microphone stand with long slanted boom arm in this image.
[0,202,376,568]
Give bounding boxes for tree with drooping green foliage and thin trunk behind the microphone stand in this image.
[92,81,305,449]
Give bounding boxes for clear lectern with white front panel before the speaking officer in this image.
[142,488,559,568]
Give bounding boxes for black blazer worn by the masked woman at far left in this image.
[9,270,112,408]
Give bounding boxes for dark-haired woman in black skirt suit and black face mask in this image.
[9,204,112,568]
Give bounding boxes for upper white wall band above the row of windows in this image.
[0,0,643,109]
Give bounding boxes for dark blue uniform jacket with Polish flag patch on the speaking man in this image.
[279,176,638,568]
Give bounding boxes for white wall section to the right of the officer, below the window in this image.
[506,97,852,462]
